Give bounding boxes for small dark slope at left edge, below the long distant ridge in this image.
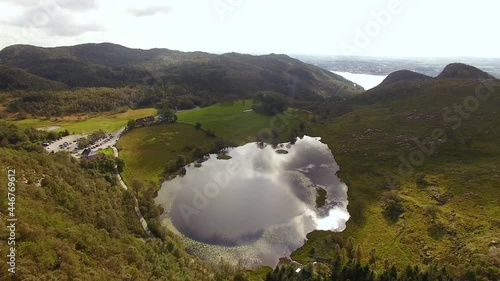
[0,64,66,90]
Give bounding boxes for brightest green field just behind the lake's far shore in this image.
[177,100,300,144]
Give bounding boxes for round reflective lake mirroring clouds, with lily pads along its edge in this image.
[156,136,349,266]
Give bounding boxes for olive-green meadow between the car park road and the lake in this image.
[117,124,219,184]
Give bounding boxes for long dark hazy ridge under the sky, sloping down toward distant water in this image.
[0,43,362,99]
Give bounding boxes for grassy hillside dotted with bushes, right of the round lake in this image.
[293,75,500,280]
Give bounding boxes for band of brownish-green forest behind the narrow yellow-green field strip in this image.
[7,85,223,118]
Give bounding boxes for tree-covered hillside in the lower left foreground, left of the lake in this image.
[0,121,240,281]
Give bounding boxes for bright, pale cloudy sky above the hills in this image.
[0,0,500,58]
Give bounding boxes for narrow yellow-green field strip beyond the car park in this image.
[13,108,156,134]
